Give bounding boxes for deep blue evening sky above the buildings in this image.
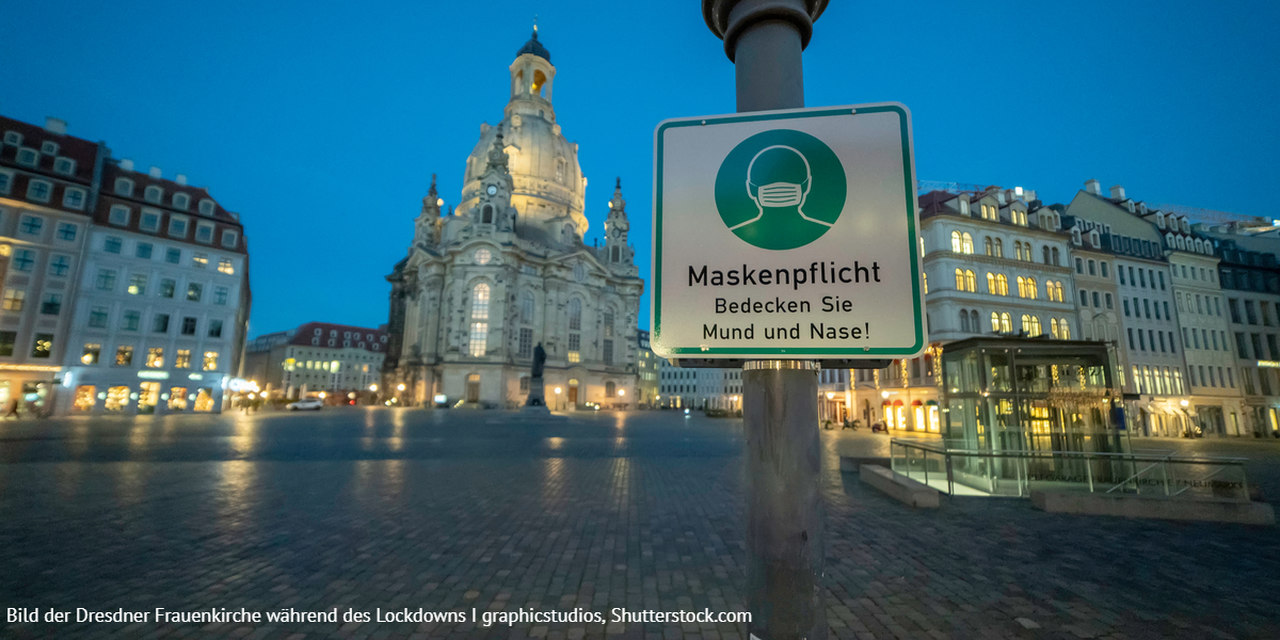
[0,0,1280,335]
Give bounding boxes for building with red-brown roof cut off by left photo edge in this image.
[0,116,99,413]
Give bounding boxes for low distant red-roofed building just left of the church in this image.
[244,323,384,402]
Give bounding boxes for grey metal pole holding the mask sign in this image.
[703,0,827,640]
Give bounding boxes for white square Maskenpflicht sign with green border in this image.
[650,104,927,358]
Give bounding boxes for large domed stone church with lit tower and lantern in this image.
[381,29,644,410]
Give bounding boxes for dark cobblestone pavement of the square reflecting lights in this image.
[0,408,1280,640]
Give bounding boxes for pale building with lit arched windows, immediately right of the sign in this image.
[849,187,1079,433]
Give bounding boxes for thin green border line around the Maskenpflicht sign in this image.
[650,102,924,358]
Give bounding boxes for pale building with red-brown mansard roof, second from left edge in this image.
[58,160,248,413]
